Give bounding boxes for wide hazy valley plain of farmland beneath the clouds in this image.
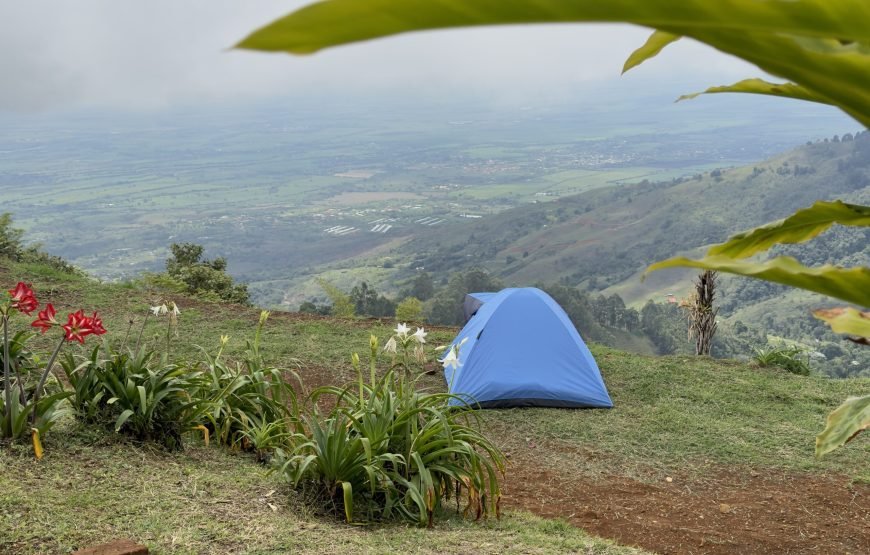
[0,93,852,305]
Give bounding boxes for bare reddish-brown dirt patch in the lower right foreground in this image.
[504,452,870,555]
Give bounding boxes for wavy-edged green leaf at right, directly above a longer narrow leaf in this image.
[707,200,870,258]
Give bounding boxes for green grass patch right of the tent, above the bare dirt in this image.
[486,346,870,482]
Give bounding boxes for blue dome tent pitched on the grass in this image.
[444,287,613,408]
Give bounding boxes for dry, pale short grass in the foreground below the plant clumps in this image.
[0,432,639,555]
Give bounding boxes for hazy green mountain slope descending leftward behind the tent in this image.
[405,133,870,294]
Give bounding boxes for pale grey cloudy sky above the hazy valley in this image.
[0,0,759,113]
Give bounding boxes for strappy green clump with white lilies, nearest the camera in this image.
[274,324,505,526]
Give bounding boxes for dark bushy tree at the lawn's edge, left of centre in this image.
[166,243,250,304]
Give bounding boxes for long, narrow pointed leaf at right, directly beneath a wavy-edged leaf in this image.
[646,255,870,306]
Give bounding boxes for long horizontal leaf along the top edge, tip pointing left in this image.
[236,0,870,54]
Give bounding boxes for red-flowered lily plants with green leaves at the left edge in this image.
[0,282,106,458]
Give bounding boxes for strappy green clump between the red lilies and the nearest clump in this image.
[62,301,296,458]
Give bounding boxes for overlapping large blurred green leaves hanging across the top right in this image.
[237,0,870,126]
